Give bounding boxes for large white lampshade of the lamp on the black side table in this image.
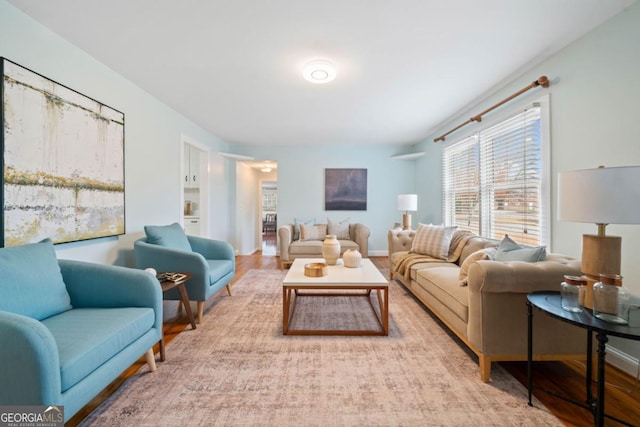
[558,166,640,224]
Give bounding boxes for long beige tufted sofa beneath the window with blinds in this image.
[388,229,586,382]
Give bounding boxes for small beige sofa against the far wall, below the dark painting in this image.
[278,224,371,268]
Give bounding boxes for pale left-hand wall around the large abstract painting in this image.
[0,1,235,265]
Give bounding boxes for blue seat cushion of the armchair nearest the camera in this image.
[42,307,155,392]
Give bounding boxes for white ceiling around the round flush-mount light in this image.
[9,0,634,145]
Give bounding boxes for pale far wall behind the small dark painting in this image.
[235,144,420,255]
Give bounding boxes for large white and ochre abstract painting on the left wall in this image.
[0,58,125,246]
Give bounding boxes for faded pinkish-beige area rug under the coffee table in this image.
[81,270,562,427]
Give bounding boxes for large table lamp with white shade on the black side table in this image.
[558,166,640,308]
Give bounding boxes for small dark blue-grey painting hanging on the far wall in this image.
[324,169,367,211]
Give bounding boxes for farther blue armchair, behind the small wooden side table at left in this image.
[134,223,236,323]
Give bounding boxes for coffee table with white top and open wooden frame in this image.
[282,258,389,335]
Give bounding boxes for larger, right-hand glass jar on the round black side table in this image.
[593,274,629,325]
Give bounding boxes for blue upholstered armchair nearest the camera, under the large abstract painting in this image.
[0,239,162,421]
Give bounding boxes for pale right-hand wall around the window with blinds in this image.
[418,3,640,364]
